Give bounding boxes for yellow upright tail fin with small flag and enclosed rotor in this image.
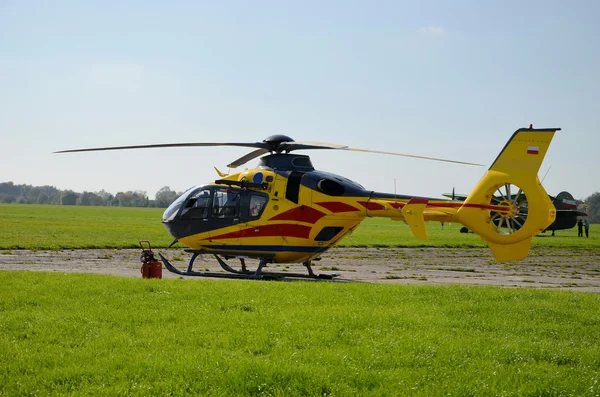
[458,128,560,261]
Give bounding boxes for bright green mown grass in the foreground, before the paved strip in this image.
[0,271,600,396]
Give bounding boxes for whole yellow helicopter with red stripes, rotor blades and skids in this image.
[56,126,560,279]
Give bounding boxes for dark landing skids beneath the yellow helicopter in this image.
[158,250,339,281]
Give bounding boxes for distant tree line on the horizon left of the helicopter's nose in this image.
[0,182,182,208]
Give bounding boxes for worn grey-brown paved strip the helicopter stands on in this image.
[0,248,600,292]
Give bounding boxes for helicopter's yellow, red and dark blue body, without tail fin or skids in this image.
[163,154,462,263]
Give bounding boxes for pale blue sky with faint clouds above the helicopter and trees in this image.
[0,0,600,198]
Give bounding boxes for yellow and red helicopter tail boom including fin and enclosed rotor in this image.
[363,128,560,262]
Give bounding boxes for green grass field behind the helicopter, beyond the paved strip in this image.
[0,204,600,249]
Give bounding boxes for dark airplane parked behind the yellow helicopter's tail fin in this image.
[443,189,587,236]
